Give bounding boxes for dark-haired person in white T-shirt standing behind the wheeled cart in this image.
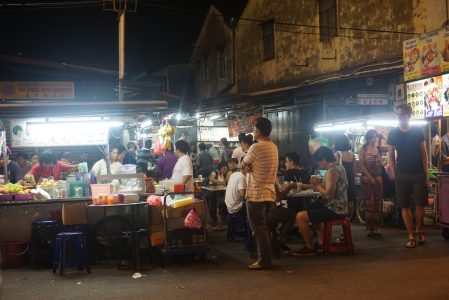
[171,140,193,192]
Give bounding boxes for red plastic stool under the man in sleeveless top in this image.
[323,218,354,255]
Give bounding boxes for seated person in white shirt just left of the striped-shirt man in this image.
[225,162,246,216]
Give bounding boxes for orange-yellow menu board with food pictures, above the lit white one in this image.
[403,27,449,81]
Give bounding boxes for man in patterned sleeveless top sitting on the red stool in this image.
[293,146,348,255]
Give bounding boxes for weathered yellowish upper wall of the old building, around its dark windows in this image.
[236,0,446,91]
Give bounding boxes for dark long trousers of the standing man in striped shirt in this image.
[246,201,274,266]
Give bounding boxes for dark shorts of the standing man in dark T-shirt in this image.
[396,172,428,208]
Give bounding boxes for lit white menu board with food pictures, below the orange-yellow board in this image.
[407,74,449,119]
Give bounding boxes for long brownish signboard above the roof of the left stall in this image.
[0,81,75,99]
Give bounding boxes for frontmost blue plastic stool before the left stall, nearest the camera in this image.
[53,231,90,275]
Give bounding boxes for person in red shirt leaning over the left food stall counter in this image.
[25,150,78,183]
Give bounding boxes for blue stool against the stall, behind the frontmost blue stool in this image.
[30,220,60,267]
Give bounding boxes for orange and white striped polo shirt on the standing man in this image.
[243,140,279,202]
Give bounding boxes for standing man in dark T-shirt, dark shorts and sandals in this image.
[388,104,427,248]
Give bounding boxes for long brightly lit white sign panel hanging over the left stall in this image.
[10,119,109,148]
